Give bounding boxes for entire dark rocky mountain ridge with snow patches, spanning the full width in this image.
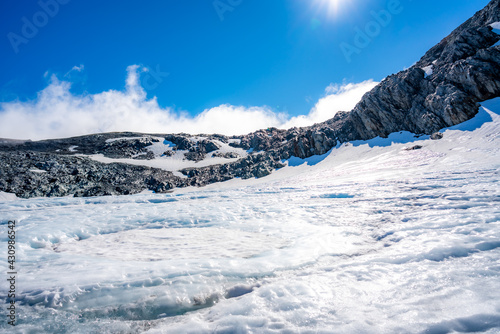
[0,0,500,198]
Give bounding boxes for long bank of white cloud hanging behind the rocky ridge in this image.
[0,65,376,140]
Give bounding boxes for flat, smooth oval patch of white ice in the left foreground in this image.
[54,227,286,261]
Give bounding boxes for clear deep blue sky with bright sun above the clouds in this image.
[0,0,489,115]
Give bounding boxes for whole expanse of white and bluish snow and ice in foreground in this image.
[0,103,500,334]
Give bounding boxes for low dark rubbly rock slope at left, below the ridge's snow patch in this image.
[0,151,179,198]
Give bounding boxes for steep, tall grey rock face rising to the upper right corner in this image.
[351,0,500,139]
